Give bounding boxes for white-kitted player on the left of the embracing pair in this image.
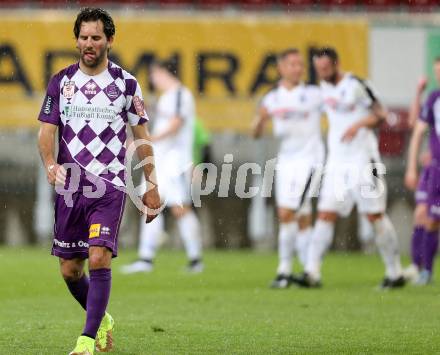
[253,48,324,288]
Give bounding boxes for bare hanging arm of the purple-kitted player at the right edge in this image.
[405,120,428,190]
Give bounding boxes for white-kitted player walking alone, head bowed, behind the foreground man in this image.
[122,61,203,273]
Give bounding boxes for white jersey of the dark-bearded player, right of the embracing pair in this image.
[321,73,380,162]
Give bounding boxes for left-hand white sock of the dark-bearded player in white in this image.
[304,219,335,280]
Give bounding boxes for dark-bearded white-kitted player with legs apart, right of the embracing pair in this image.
[300,48,405,288]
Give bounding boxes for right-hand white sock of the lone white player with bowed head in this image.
[177,211,202,260]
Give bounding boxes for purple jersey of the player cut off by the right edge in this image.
[420,89,440,166]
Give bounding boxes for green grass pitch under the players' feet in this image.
[0,248,440,355]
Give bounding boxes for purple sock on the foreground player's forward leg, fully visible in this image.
[83,269,112,339]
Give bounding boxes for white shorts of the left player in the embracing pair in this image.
[275,158,317,214]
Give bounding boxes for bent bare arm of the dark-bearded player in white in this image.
[342,82,387,142]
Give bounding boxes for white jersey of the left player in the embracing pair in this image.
[262,84,324,163]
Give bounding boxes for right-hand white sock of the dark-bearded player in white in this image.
[373,215,402,280]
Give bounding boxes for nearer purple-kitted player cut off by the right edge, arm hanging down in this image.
[405,58,440,285]
